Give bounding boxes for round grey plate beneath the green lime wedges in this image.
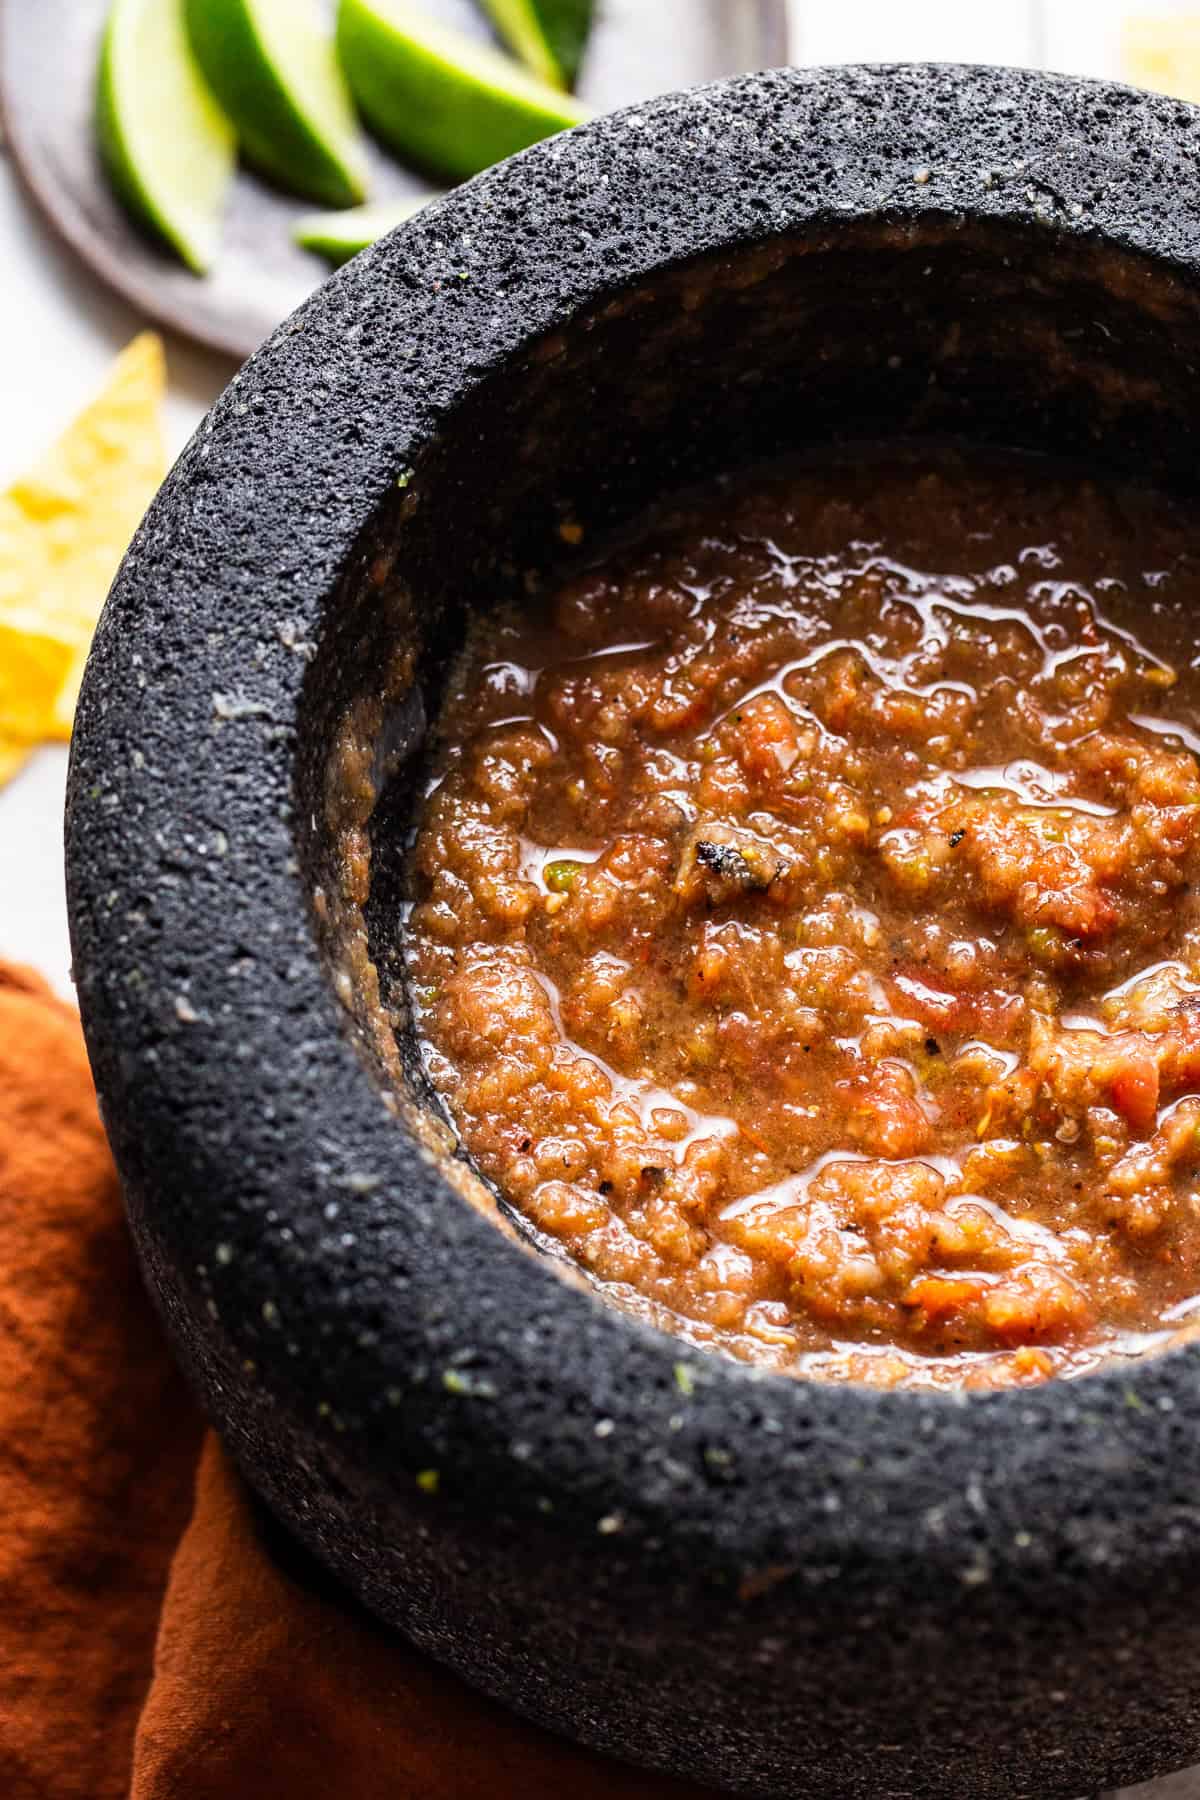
[0,0,786,358]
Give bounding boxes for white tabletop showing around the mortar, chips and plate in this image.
[0,0,1200,1800]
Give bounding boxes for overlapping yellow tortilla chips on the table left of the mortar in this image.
[0,331,167,752]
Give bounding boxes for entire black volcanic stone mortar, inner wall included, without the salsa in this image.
[67,56,1200,1800]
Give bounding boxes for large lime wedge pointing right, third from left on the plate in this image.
[338,0,587,176]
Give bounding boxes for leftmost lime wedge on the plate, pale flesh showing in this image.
[95,0,236,275]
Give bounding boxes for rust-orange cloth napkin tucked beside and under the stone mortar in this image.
[0,965,707,1800]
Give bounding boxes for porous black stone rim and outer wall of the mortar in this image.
[67,67,1200,1800]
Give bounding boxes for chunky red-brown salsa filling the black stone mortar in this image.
[405,448,1200,1386]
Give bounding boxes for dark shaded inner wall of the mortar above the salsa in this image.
[299,218,1200,1118]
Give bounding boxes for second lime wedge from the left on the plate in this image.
[184,0,367,207]
